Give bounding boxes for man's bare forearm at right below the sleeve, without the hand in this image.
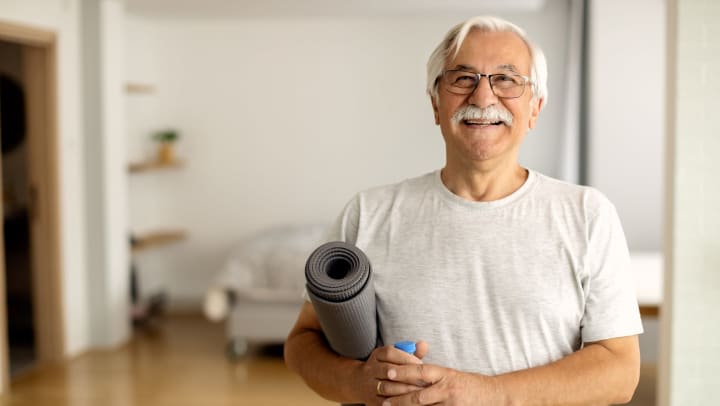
[496,337,640,406]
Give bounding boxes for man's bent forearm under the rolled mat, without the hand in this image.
[285,329,362,403]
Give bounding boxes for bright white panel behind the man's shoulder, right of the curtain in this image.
[587,0,665,251]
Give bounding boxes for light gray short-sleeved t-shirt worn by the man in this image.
[331,170,642,375]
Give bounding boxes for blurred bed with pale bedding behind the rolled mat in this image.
[204,224,326,359]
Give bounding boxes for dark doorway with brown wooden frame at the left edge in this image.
[0,21,65,393]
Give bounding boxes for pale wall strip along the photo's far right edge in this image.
[658,0,720,406]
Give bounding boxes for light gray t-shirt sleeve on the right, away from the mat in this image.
[581,200,643,343]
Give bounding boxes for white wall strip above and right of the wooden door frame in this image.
[0,0,89,355]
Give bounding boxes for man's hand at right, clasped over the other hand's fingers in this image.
[376,364,500,406]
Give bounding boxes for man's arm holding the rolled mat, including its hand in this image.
[284,303,422,405]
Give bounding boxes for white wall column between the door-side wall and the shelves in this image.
[82,0,130,347]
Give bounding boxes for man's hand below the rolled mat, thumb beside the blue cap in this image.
[357,341,428,405]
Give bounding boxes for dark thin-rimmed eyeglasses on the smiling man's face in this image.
[438,69,533,99]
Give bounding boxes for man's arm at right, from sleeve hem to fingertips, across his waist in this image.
[383,336,640,406]
